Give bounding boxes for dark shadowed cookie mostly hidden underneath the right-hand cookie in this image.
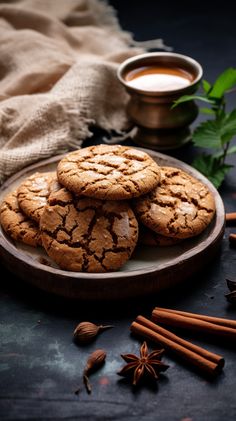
[138,224,183,247]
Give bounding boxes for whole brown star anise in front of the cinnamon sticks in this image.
[117,342,169,386]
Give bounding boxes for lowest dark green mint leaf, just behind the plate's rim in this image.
[192,155,233,189]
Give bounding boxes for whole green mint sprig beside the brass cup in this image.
[173,68,236,188]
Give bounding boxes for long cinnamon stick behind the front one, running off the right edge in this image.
[152,309,236,341]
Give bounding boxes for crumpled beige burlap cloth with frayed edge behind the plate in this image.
[0,0,167,184]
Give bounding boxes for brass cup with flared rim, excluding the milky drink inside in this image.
[117,52,203,150]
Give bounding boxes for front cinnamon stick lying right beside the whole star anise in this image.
[131,321,221,375]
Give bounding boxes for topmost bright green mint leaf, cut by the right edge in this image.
[209,67,236,98]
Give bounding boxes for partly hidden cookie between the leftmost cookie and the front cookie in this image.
[17,172,56,224]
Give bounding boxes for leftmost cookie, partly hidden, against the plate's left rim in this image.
[0,191,41,247]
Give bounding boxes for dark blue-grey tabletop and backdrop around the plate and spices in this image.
[0,0,236,421]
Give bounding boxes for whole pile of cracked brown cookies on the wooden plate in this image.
[0,145,215,272]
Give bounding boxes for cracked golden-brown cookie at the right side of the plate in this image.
[134,167,215,238]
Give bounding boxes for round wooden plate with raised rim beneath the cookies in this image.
[0,149,225,300]
